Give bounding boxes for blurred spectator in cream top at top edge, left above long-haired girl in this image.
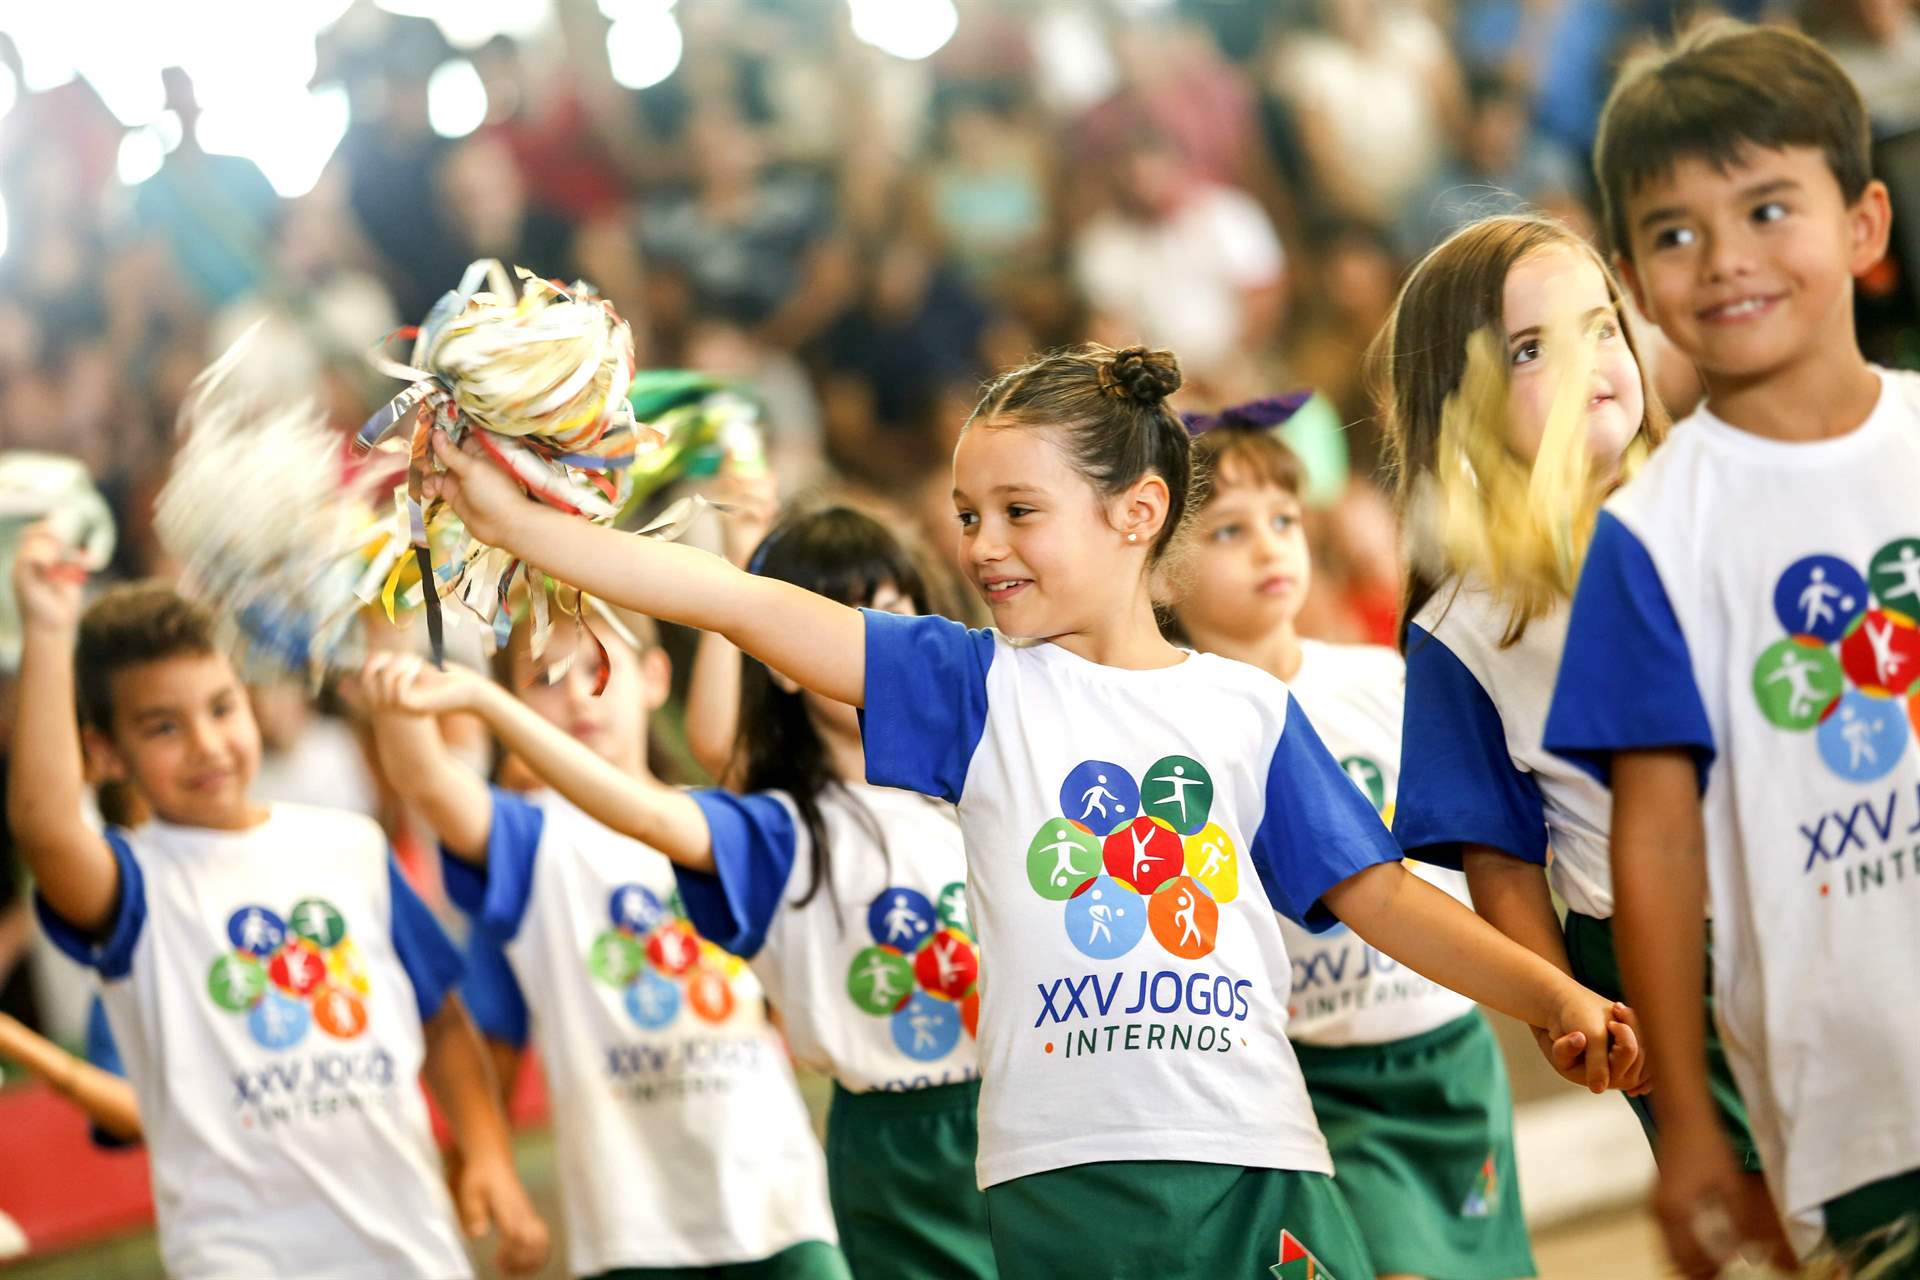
[1267,0,1463,226]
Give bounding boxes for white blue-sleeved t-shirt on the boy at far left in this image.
[38,804,472,1280]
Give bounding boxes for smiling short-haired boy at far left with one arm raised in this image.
[8,528,547,1280]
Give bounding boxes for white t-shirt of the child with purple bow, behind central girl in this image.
[1281,641,1473,1046]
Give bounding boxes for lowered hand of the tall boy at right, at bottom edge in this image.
[1653,1119,1795,1280]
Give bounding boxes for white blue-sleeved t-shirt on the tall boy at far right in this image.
[1546,372,1920,1245]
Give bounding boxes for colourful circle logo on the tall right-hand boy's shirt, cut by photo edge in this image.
[1753,537,1920,783]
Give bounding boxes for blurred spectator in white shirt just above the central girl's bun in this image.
[1073,132,1286,393]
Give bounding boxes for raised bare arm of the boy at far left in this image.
[6,524,121,935]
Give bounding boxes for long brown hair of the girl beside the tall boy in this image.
[1367,215,1668,649]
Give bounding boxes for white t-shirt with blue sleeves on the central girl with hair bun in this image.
[864,612,1400,1186]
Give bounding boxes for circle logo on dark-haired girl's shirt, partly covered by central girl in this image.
[847,881,979,1061]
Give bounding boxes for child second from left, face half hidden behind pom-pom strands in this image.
[361,602,847,1280]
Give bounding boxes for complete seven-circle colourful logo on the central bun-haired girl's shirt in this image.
[1027,756,1240,960]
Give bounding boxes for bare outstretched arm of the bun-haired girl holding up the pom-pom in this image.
[426,432,866,706]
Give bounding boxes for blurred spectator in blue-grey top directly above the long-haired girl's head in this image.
[1394,73,1594,261]
